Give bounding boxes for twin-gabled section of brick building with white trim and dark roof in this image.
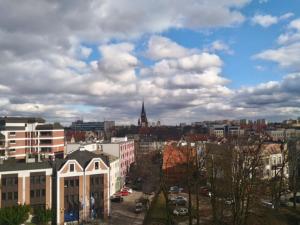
[55,150,109,224]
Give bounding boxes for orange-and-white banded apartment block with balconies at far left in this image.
[0,117,64,159]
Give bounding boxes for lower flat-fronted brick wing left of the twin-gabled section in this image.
[0,159,52,208]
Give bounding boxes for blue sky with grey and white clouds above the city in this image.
[0,0,300,124]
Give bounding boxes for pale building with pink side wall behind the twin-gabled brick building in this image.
[99,137,135,183]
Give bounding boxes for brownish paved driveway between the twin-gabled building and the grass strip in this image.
[108,191,146,225]
